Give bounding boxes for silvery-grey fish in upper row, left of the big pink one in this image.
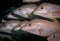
[12,4,37,18]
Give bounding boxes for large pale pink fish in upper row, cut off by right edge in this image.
[33,3,60,18]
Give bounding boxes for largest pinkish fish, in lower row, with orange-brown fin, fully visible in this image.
[21,19,60,37]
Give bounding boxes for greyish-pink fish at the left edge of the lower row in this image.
[0,20,21,33]
